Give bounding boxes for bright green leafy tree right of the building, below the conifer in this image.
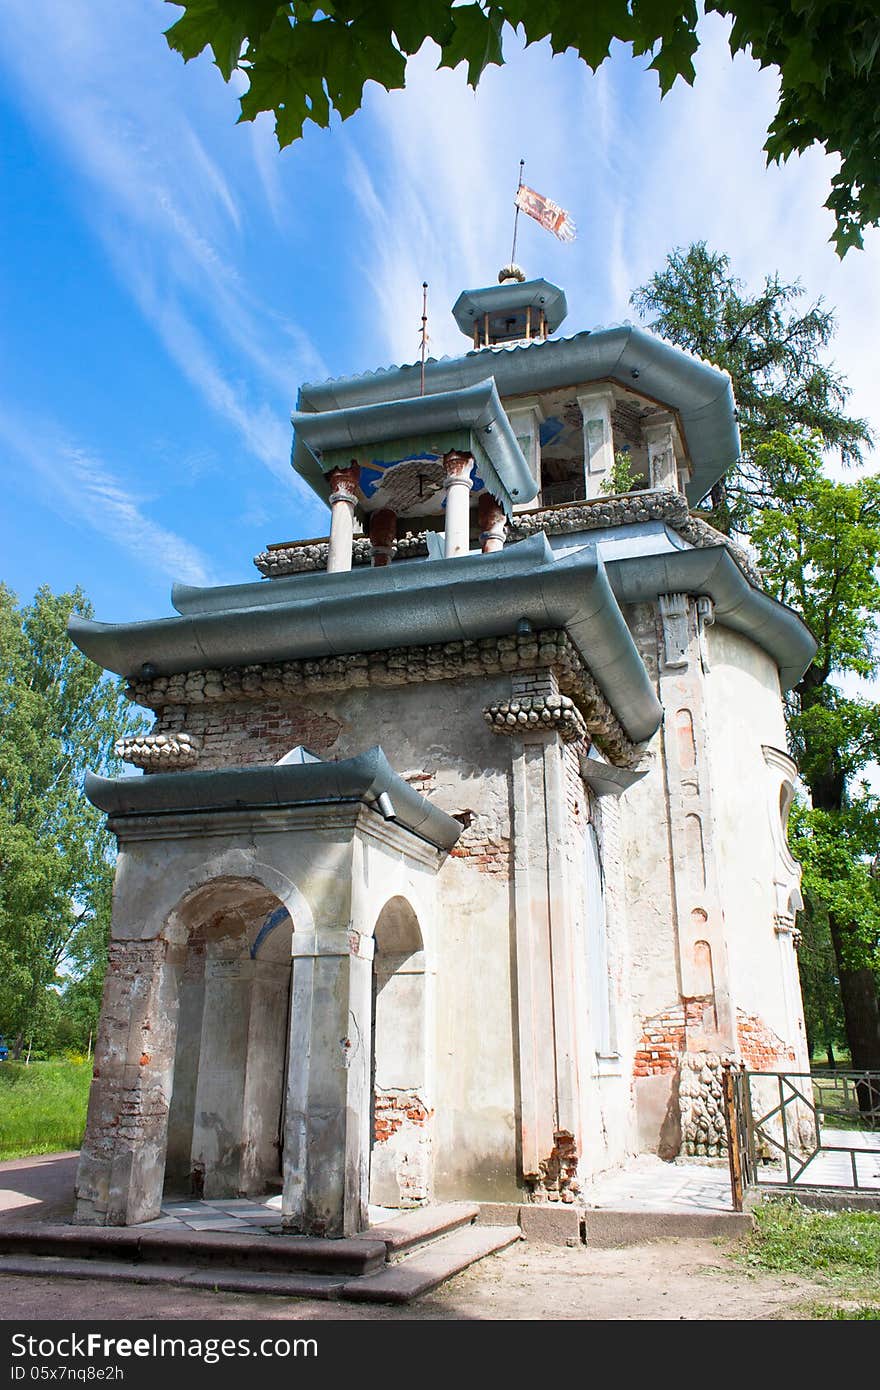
[751,432,880,1070]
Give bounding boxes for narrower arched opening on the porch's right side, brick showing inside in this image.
[370,897,434,1208]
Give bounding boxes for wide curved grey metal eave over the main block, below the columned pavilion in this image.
[68,532,660,750]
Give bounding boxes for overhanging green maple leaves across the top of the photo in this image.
[167,0,880,256]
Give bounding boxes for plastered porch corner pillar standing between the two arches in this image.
[282,927,374,1236]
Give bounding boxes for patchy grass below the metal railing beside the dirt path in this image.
[741,1201,880,1321]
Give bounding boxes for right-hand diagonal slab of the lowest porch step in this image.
[341,1226,523,1302]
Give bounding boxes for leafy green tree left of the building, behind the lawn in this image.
[0,585,139,1056]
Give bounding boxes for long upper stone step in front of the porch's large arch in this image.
[0,1223,388,1277]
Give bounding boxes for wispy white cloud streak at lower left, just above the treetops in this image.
[0,406,210,584]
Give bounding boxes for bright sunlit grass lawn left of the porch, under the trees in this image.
[0,1058,92,1159]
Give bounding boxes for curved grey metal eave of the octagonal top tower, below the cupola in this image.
[293,324,740,505]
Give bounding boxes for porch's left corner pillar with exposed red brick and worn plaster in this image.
[75,937,184,1226]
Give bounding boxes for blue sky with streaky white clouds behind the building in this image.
[0,0,880,620]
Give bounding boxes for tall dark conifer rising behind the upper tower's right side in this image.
[630,242,870,531]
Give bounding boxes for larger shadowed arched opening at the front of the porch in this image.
[165,878,293,1198]
